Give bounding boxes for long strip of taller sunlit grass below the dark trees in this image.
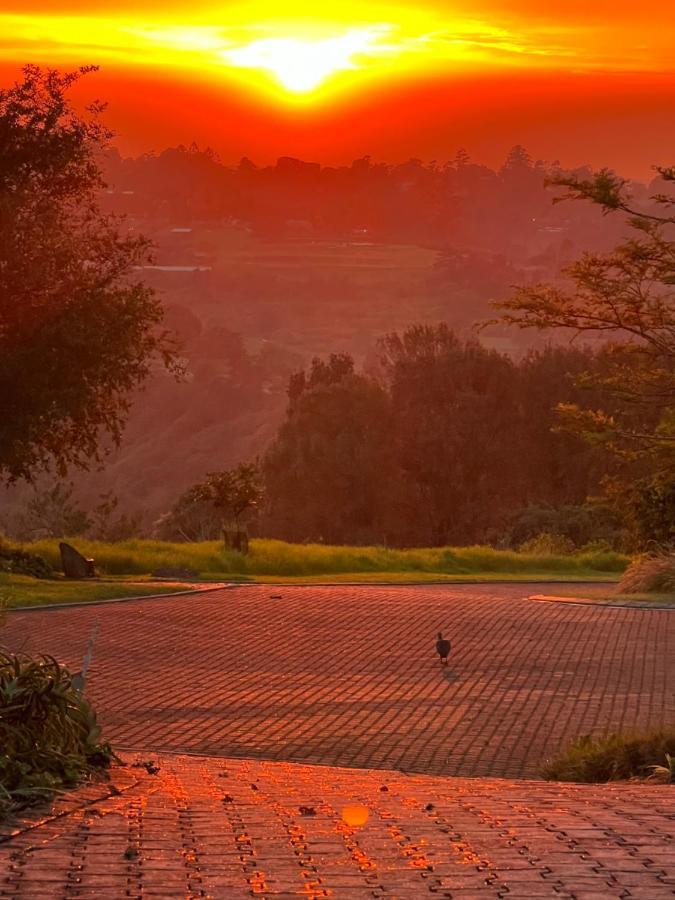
[17,538,629,581]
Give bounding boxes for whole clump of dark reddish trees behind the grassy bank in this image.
[259,325,656,546]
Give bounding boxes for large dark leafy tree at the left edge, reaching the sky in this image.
[0,66,174,481]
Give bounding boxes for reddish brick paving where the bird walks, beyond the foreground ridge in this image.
[2,585,675,778]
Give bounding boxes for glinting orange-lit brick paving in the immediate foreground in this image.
[0,756,675,900]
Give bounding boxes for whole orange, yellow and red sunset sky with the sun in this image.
[0,0,675,175]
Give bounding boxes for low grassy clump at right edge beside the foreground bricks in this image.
[542,729,675,783]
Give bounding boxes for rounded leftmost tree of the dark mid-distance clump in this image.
[261,354,396,543]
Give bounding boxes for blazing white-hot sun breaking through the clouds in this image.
[222,26,388,95]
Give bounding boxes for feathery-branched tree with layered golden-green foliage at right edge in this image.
[496,162,675,482]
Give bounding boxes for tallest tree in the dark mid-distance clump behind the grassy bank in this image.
[380,325,517,545]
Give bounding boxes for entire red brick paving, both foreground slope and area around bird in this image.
[0,586,675,900]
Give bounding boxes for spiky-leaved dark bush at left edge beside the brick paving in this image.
[0,651,114,818]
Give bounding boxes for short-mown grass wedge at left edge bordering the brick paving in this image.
[0,573,190,609]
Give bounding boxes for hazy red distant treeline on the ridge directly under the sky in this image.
[100,146,654,256]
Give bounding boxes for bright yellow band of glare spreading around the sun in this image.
[0,0,672,108]
